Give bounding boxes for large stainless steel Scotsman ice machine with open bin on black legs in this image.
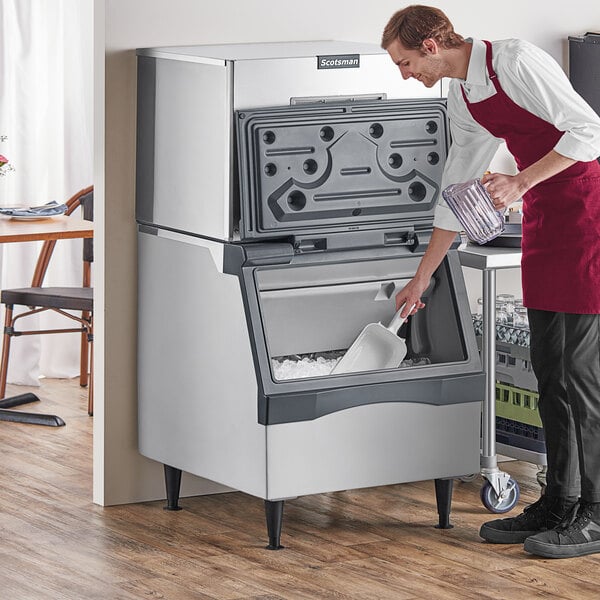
[136,41,484,548]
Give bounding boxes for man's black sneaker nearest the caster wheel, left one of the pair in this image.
[479,496,577,544]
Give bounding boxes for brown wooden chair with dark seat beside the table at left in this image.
[0,186,94,416]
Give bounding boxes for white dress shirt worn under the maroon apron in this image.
[433,39,600,231]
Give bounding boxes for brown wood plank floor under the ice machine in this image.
[0,380,600,600]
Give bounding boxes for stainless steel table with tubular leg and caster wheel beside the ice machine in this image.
[458,244,521,512]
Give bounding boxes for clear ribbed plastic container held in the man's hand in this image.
[442,179,504,244]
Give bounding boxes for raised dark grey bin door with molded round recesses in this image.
[236,100,449,239]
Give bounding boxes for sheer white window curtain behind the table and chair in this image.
[0,0,93,385]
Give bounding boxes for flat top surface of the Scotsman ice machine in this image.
[137,40,386,62]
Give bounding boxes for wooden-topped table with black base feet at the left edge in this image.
[0,216,94,427]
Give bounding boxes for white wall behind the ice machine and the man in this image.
[94,0,600,504]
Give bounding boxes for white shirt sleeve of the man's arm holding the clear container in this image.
[496,40,600,162]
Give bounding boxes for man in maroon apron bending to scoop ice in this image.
[381,6,600,557]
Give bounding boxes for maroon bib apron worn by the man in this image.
[461,41,600,314]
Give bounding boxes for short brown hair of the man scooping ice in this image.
[381,4,464,50]
